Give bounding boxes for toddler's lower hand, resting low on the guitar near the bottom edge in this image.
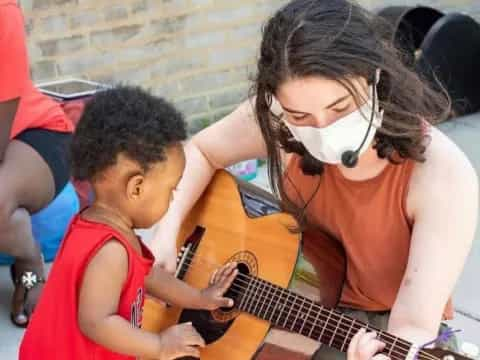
[156,322,205,360]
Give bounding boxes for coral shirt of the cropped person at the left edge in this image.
[0,0,73,138]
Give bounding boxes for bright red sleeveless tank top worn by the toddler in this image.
[19,215,153,360]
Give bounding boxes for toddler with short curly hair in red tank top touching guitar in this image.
[20,86,237,360]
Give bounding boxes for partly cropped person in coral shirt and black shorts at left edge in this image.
[0,0,73,327]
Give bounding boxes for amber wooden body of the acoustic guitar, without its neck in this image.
[142,171,344,360]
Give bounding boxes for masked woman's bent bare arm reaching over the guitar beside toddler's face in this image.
[151,100,267,271]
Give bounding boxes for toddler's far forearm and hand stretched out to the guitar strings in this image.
[145,263,237,310]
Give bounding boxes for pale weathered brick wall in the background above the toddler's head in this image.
[20,0,480,131]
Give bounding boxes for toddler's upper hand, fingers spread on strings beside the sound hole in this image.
[201,262,238,310]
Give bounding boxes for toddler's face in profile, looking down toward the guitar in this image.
[128,145,185,228]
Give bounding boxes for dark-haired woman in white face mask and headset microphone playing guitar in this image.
[153,0,478,359]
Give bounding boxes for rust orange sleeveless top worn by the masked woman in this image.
[284,155,452,318]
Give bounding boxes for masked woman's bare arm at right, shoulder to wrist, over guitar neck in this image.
[389,129,478,343]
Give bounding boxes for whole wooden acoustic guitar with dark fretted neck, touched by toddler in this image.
[142,171,467,360]
